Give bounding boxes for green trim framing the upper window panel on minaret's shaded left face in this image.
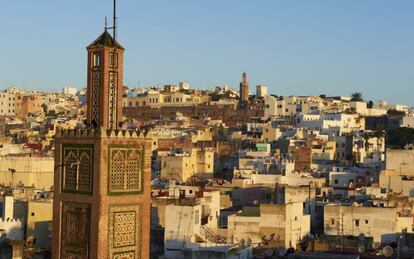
[58,143,95,196]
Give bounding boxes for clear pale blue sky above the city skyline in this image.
[0,0,414,106]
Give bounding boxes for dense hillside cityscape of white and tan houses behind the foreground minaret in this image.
[0,76,414,258]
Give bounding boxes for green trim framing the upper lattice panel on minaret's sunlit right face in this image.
[107,144,145,196]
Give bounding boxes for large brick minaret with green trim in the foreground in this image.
[52,0,152,259]
